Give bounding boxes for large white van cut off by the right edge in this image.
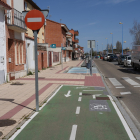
[131,45,140,70]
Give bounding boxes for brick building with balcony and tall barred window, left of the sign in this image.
[5,0,27,81]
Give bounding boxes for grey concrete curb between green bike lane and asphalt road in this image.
[95,58,140,140]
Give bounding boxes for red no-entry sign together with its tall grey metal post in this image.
[23,10,49,112]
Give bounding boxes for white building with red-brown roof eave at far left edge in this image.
[0,0,12,84]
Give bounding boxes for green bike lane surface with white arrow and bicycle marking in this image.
[14,86,135,140]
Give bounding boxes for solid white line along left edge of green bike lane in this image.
[9,85,63,140]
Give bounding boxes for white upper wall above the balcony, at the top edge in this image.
[14,0,24,13]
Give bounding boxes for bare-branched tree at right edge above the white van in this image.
[129,20,140,45]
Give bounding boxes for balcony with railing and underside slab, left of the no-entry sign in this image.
[7,9,27,32]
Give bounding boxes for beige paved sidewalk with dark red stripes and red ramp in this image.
[0,60,104,139]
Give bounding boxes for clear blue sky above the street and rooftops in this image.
[33,0,140,52]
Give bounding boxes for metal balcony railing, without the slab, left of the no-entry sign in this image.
[7,9,27,30]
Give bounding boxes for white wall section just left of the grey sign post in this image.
[26,38,35,72]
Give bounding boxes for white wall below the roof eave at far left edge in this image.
[0,8,7,84]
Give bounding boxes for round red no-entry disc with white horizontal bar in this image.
[25,10,45,30]
